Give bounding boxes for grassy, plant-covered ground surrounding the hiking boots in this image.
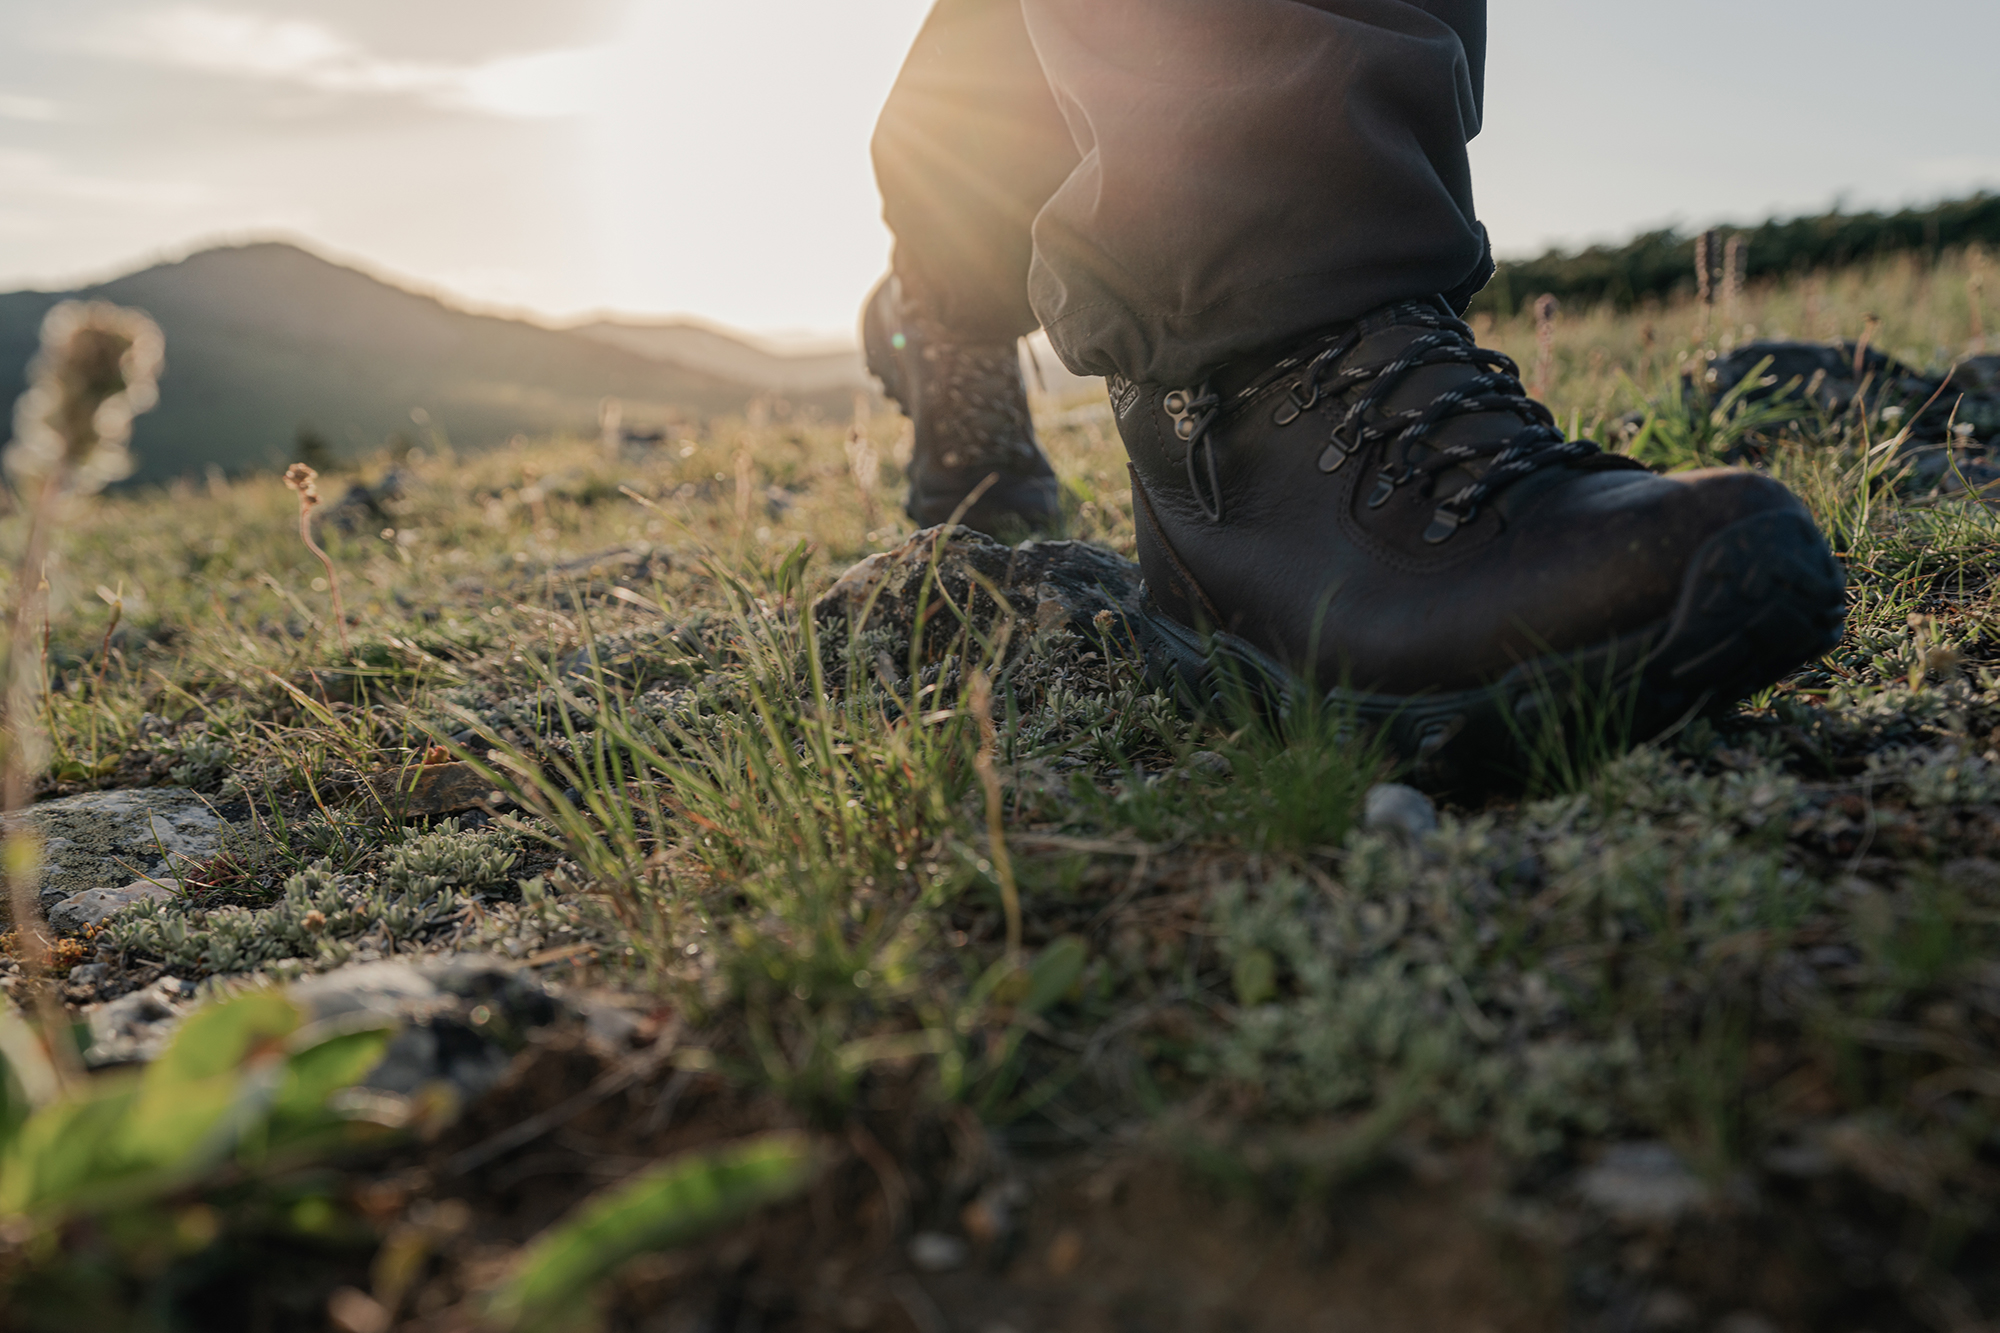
[4,246,2000,1329]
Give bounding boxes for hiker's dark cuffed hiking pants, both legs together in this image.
[874,0,1492,384]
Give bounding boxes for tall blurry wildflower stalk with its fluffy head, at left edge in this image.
[0,300,164,1024]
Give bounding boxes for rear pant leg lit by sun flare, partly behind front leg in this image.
[872,0,1078,340]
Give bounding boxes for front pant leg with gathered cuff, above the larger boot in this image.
[1022,0,1492,384]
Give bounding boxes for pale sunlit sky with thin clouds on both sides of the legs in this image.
[0,0,2000,338]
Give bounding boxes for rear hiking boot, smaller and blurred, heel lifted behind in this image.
[862,274,1062,536]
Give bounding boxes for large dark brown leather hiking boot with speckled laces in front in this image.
[1110,302,1846,787]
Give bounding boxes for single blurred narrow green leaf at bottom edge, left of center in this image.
[490,1133,818,1333]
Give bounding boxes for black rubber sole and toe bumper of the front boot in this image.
[1136,512,1846,793]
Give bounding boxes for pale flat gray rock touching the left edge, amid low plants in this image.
[8,787,224,911]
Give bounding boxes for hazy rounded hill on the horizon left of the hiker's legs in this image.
[0,242,852,480]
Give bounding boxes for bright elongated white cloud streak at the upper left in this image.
[86,4,604,118]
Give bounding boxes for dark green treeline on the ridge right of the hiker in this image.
[1472,192,2000,314]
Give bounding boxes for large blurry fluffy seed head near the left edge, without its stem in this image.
[6,300,166,494]
